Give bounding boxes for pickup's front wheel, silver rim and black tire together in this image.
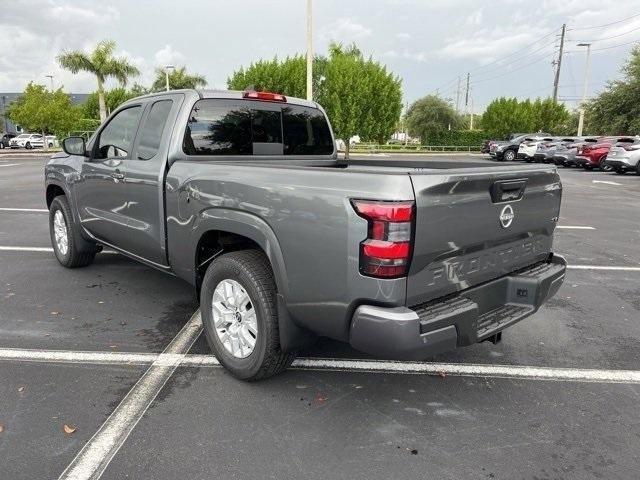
[49,195,98,268]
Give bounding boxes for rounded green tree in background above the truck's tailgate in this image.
[406,95,463,144]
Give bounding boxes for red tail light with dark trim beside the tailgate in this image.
[352,200,415,278]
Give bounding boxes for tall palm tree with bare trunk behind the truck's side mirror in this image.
[58,40,140,122]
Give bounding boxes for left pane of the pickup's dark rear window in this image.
[183,100,253,155]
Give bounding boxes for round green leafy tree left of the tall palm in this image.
[7,82,81,149]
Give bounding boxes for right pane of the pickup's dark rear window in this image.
[282,105,334,155]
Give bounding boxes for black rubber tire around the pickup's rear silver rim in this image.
[200,250,295,381]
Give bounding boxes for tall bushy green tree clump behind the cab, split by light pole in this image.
[227,44,402,158]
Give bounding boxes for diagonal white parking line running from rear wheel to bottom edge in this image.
[59,310,202,480]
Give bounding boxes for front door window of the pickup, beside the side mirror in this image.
[94,106,141,159]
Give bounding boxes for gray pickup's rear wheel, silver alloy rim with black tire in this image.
[200,250,295,381]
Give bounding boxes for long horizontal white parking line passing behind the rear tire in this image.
[0,348,640,384]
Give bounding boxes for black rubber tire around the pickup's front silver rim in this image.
[49,195,99,268]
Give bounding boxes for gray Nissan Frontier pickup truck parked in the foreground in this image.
[45,90,566,380]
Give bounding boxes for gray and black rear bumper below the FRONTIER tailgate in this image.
[350,255,567,360]
